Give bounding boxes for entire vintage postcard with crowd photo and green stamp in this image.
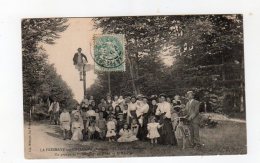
[21,14,247,159]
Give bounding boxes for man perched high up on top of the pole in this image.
[73,48,88,81]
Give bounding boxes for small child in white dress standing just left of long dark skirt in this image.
[147,117,162,144]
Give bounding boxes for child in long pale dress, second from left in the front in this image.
[71,114,84,141]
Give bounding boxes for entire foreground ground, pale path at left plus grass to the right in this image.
[25,121,247,158]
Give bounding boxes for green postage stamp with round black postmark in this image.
[94,34,125,71]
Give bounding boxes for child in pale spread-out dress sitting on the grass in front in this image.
[117,124,138,142]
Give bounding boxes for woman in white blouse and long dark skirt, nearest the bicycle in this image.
[156,94,177,145]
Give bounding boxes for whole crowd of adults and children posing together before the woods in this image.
[49,91,200,147]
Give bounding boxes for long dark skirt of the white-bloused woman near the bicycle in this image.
[159,118,177,145]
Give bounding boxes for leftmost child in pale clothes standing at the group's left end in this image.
[60,108,71,140]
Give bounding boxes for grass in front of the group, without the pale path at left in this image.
[30,119,247,158]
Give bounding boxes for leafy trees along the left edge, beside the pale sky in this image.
[22,18,75,111]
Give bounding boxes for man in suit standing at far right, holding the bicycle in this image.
[185,91,201,147]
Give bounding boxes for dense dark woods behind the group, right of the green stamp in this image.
[93,15,244,112]
